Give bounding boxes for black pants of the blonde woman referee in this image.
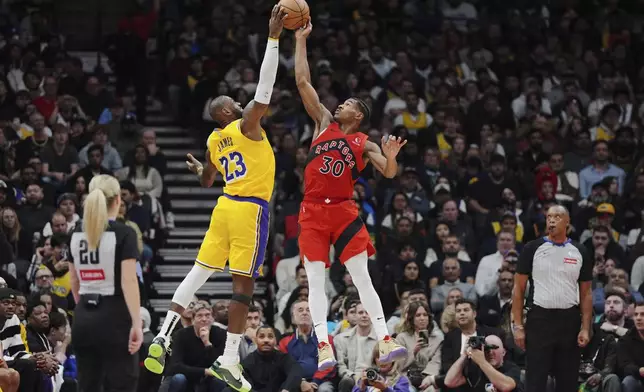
[72,296,139,392]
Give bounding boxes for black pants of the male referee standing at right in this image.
[525,306,581,392]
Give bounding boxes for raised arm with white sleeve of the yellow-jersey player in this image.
[241,5,286,140]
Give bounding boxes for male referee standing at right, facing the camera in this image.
[512,206,593,392]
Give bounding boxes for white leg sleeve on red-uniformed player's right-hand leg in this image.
[348,251,389,340]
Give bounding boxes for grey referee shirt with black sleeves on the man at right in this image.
[517,237,593,309]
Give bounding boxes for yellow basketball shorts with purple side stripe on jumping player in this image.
[196,194,270,278]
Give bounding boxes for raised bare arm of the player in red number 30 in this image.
[295,22,333,140]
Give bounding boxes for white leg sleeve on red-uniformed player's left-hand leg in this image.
[304,257,329,343]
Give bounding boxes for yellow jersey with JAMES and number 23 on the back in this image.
[207,120,275,201]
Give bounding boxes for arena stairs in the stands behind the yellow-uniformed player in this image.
[146,120,267,328]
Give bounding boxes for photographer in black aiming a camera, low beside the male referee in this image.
[445,335,522,392]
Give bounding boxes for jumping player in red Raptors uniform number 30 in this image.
[295,23,407,370]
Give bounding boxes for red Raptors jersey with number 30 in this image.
[304,122,367,203]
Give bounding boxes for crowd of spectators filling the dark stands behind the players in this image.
[0,0,644,392]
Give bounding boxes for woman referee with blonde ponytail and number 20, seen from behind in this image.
[69,175,143,392]
